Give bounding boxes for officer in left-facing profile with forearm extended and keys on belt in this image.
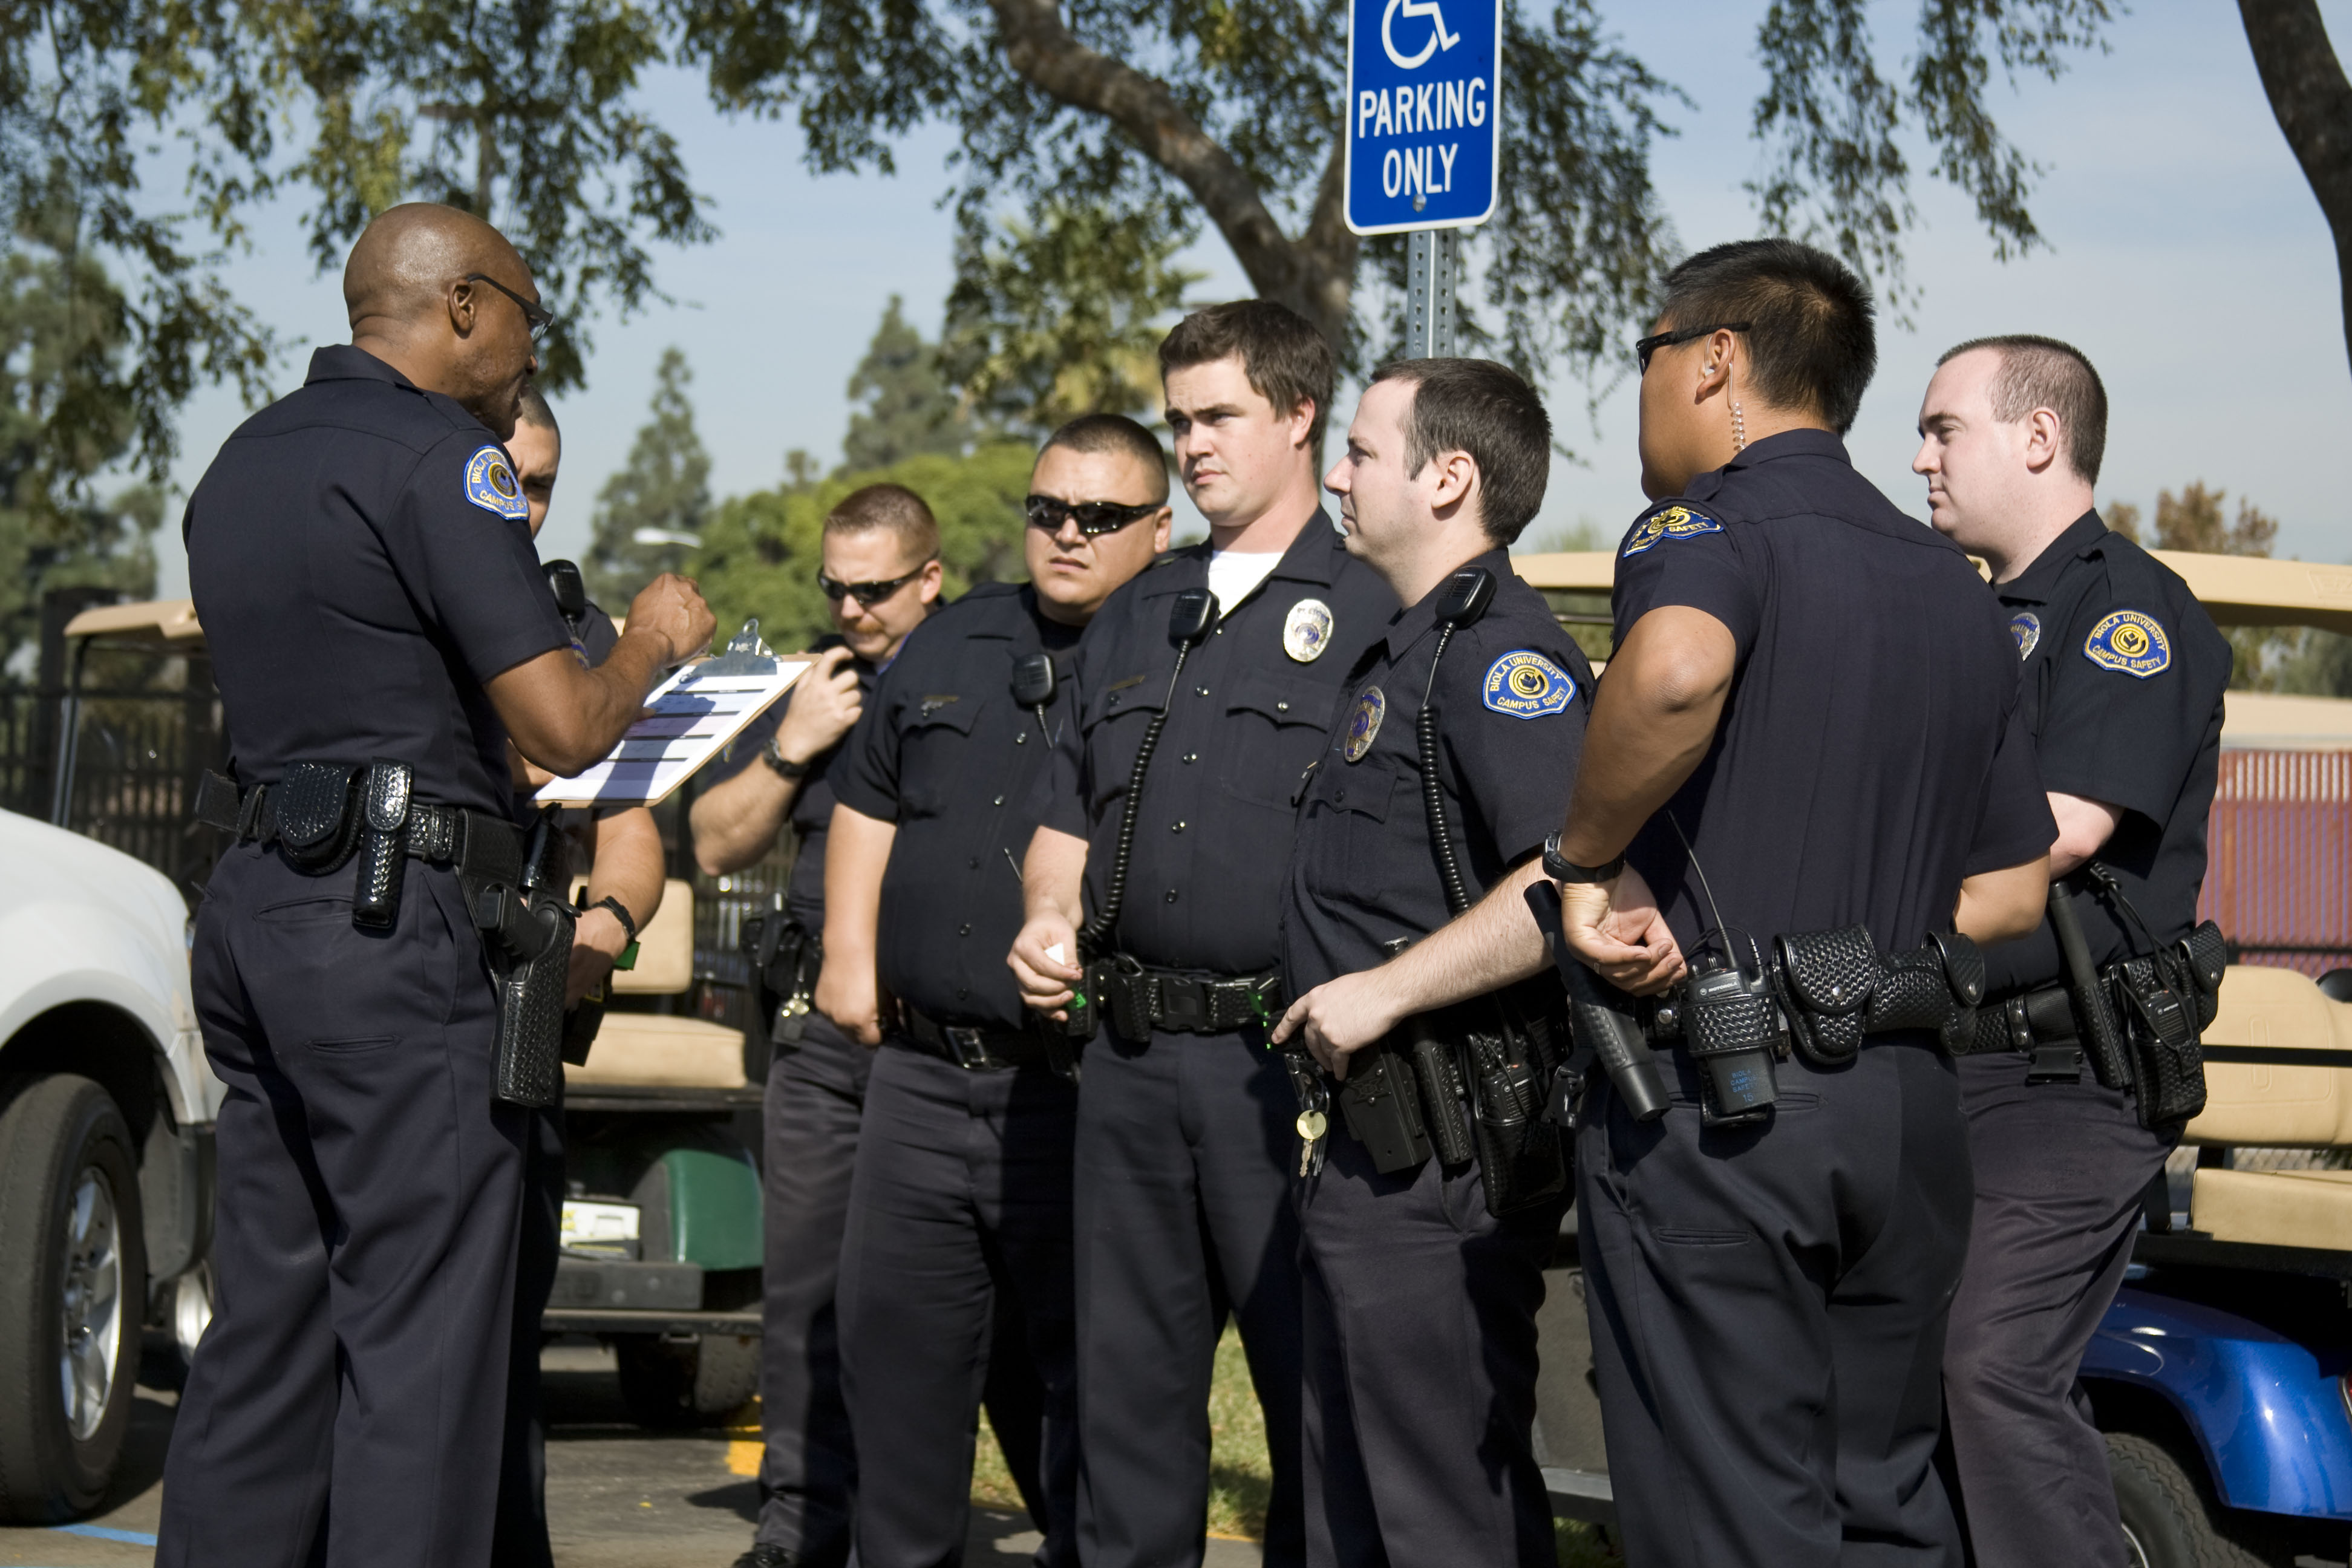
[1275,360,1592,1568]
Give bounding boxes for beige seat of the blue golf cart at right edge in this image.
[2183,964,2352,1250]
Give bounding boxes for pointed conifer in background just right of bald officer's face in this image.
[583,348,710,606]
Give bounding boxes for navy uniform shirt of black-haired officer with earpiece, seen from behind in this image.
[1611,430,2058,961]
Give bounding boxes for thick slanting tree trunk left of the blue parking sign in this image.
[988,0,1362,348]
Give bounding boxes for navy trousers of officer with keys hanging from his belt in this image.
[1298,1105,1571,1568]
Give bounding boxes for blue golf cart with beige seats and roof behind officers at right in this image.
[1515,550,2352,1568]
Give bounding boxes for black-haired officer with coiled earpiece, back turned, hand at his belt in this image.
[1545,240,2053,1568]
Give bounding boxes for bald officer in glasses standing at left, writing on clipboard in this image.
[157,204,710,1568]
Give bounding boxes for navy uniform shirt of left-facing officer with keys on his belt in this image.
[1282,550,1592,997]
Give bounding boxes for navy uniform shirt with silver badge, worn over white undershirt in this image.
[1044,512,1397,976]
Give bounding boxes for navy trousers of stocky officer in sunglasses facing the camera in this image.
[835,1044,1077,1568]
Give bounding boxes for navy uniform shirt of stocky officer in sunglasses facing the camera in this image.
[830,583,1077,1030]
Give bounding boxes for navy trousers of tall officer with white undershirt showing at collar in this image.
[1075,1030,1305,1568]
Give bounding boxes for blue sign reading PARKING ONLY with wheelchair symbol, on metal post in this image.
[1348,0,1503,235]
